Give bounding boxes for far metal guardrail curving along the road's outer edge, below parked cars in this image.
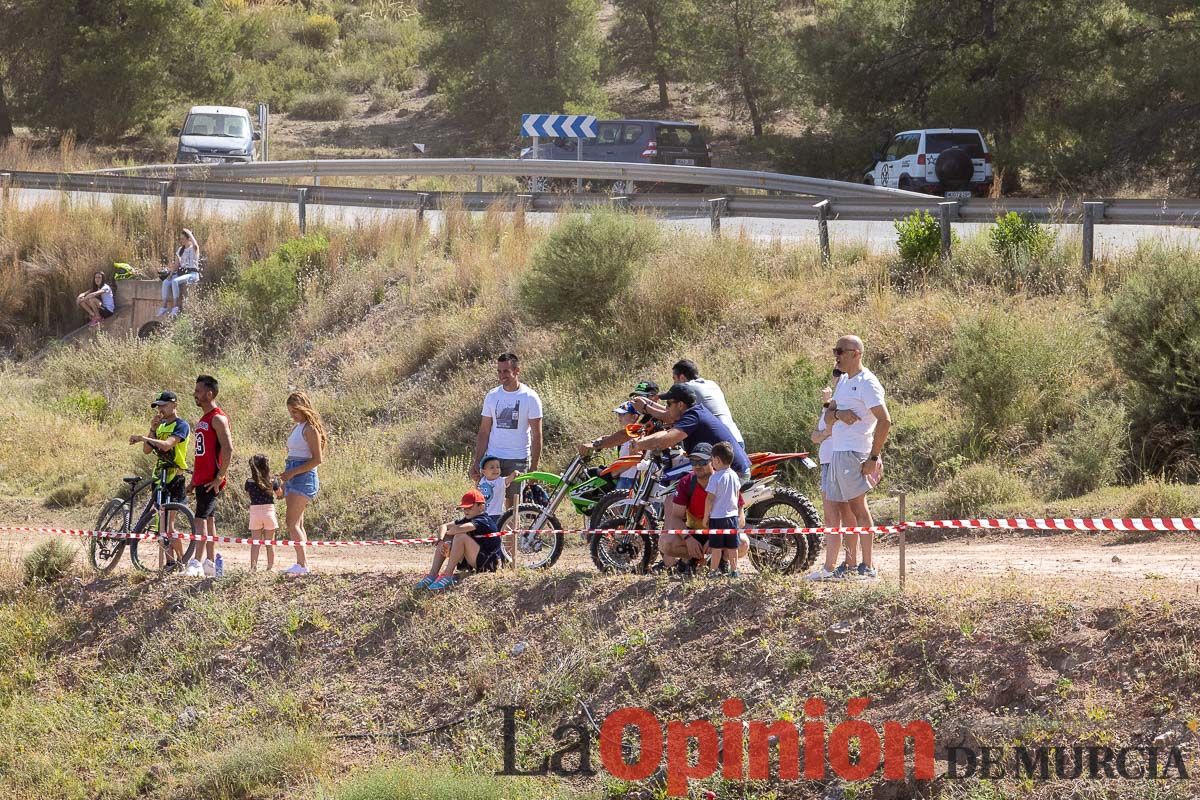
[88,158,920,199]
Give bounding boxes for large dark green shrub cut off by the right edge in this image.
[1104,251,1200,470]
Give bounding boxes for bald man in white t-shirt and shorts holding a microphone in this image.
[809,336,892,581]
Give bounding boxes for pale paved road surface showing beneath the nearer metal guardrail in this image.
[2,190,1200,257]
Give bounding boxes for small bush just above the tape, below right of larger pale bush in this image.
[1050,401,1129,498]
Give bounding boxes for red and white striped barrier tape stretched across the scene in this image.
[0,517,1200,547]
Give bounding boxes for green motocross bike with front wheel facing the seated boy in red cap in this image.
[499,456,641,570]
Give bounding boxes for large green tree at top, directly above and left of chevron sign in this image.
[421,0,605,137]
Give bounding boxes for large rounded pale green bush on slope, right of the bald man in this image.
[947,312,1094,446]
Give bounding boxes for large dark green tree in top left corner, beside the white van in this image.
[0,0,233,140]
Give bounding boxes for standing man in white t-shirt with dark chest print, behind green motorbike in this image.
[470,353,541,507]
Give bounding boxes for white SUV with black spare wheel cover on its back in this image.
[863,128,991,199]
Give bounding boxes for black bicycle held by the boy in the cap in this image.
[88,464,196,575]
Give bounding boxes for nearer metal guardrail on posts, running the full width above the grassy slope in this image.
[7,170,1200,227]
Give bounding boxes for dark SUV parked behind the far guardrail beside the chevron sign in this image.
[521,120,713,192]
